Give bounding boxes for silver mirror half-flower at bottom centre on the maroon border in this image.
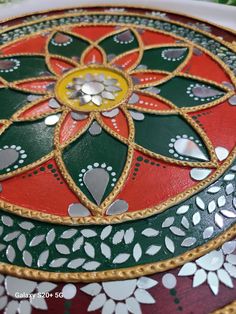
[81,277,158,314]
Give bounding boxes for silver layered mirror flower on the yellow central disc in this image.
[67,74,121,106]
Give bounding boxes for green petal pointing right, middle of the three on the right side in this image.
[158,76,226,108]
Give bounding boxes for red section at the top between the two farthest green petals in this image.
[71,26,115,41]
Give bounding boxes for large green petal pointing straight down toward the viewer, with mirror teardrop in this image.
[63,124,127,204]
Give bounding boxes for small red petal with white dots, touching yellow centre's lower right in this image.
[101,109,129,139]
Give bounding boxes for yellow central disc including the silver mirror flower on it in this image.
[55,66,132,112]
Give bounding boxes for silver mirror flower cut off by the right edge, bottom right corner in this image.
[178,240,236,295]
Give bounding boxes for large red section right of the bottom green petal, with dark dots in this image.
[114,151,205,211]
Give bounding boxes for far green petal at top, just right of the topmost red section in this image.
[99,30,139,59]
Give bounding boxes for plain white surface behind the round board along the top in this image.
[0,0,236,29]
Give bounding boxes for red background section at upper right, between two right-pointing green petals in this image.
[182,50,230,83]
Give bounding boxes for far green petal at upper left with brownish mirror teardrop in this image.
[48,32,89,58]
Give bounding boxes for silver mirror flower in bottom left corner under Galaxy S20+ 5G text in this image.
[0,275,57,314]
